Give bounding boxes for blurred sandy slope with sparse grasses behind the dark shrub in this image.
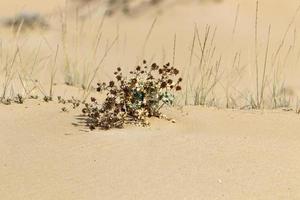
[0,0,300,107]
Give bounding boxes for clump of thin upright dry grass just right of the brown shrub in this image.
[185,26,222,105]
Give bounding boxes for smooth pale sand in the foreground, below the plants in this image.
[0,102,300,200]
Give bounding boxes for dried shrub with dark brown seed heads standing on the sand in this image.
[82,61,182,130]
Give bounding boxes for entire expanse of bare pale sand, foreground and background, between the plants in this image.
[0,0,300,200]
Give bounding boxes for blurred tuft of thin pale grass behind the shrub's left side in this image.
[60,9,113,92]
